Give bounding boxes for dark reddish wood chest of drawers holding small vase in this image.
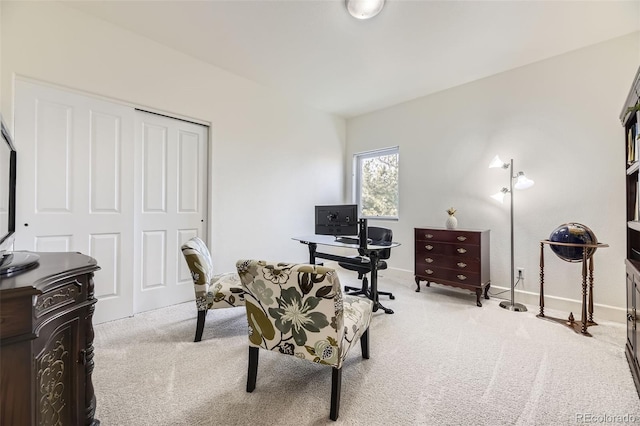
[414,228,491,306]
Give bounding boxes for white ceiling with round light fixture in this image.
[67,0,640,117]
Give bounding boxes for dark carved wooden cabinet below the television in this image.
[0,253,100,426]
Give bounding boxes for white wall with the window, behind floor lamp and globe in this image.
[346,33,640,321]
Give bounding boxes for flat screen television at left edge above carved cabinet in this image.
[0,116,16,253]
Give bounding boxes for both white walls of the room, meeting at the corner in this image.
[0,1,640,321]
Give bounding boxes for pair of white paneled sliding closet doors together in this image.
[14,80,208,323]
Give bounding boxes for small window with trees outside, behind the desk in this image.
[353,146,399,219]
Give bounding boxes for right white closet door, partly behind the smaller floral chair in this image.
[134,112,208,312]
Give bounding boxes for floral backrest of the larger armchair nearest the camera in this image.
[236,260,352,368]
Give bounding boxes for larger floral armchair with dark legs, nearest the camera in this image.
[236,260,373,420]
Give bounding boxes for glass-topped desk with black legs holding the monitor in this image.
[293,235,400,314]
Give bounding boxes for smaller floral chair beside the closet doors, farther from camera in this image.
[181,237,244,342]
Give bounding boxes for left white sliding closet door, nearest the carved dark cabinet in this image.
[14,80,135,323]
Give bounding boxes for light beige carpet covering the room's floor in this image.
[93,270,640,426]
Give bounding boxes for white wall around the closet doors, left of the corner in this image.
[0,2,345,271]
